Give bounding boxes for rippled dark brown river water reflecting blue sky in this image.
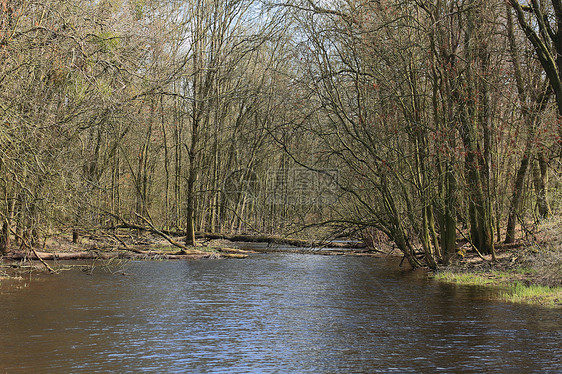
[0,253,562,373]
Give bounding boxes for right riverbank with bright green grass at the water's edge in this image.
[432,241,562,308]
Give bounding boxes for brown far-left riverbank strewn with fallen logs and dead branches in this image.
[0,226,378,276]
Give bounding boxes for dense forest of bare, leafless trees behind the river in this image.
[0,0,562,268]
